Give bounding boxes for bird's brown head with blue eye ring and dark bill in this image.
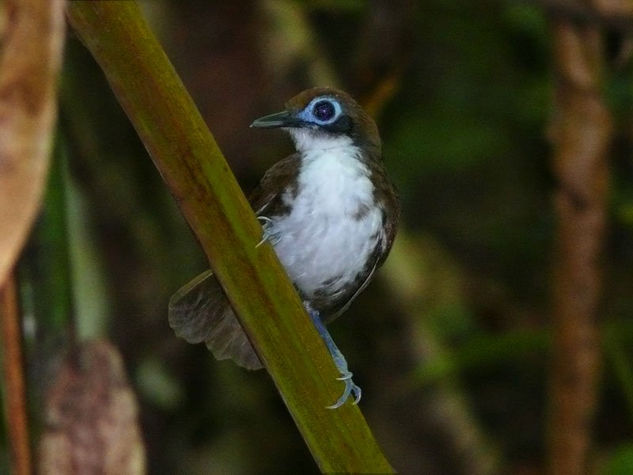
[251,87,380,152]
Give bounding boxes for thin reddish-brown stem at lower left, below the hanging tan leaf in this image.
[0,276,31,475]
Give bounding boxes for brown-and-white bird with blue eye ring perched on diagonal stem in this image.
[168,87,400,409]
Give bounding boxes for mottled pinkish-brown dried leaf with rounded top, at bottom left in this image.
[39,341,145,475]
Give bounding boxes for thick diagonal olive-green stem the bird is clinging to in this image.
[68,0,393,472]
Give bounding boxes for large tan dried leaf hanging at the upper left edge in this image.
[0,0,65,285]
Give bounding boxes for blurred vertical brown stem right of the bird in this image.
[549,11,611,474]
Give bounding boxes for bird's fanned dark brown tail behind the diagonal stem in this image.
[169,270,262,369]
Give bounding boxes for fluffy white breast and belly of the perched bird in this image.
[270,144,382,298]
